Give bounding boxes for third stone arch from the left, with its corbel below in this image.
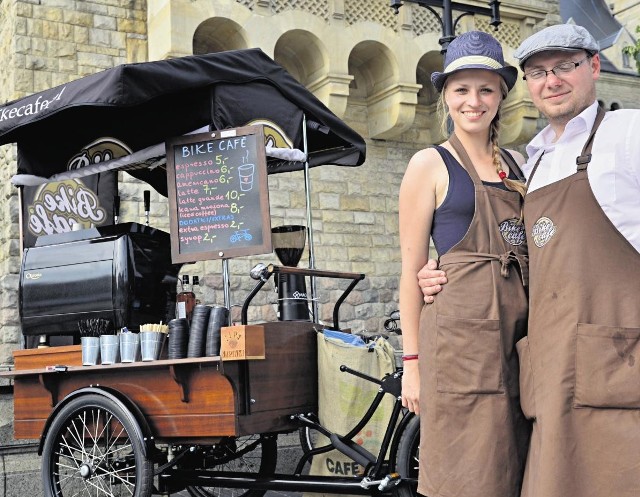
[348,40,419,139]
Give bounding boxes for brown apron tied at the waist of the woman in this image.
[418,135,530,497]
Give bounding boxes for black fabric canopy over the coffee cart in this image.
[0,49,365,195]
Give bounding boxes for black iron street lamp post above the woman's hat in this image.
[391,0,502,54]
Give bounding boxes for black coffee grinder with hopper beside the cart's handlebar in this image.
[271,225,309,321]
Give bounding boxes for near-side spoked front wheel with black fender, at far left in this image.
[42,394,153,497]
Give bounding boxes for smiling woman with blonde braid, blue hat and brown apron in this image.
[400,31,529,497]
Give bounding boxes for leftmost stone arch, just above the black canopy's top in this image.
[193,17,249,55]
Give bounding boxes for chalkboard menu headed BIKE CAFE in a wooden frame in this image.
[166,126,272,263]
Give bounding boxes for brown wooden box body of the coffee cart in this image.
[3,322,317,443]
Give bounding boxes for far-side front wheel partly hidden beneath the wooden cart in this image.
[187,435,278,497]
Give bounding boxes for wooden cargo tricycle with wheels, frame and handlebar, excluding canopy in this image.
[7,266,419,497]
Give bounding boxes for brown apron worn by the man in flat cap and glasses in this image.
[518,109,640,497]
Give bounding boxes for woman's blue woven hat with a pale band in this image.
[431,31,518,92]
